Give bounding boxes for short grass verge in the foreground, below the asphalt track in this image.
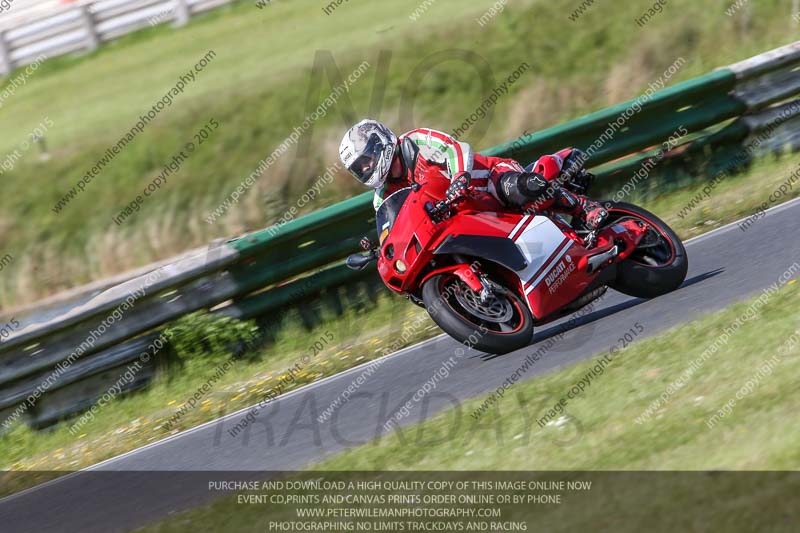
[144,283,800,532]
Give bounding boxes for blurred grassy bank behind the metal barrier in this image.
[0,0,794,307]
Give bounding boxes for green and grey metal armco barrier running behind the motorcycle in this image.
[0,42,800,431]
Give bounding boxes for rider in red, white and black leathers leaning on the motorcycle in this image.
[339,119,608,237]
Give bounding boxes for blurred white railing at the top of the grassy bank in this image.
[0,0,233,76]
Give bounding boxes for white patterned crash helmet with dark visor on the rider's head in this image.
[339,119,397,189]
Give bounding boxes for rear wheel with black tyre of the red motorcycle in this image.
[603,202,689,298]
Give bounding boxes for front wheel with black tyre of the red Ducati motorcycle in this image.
[422,274,533,354]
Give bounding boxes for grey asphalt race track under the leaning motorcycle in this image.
[0,200,800,532]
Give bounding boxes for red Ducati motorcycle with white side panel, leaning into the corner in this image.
[347,168,688,354]
